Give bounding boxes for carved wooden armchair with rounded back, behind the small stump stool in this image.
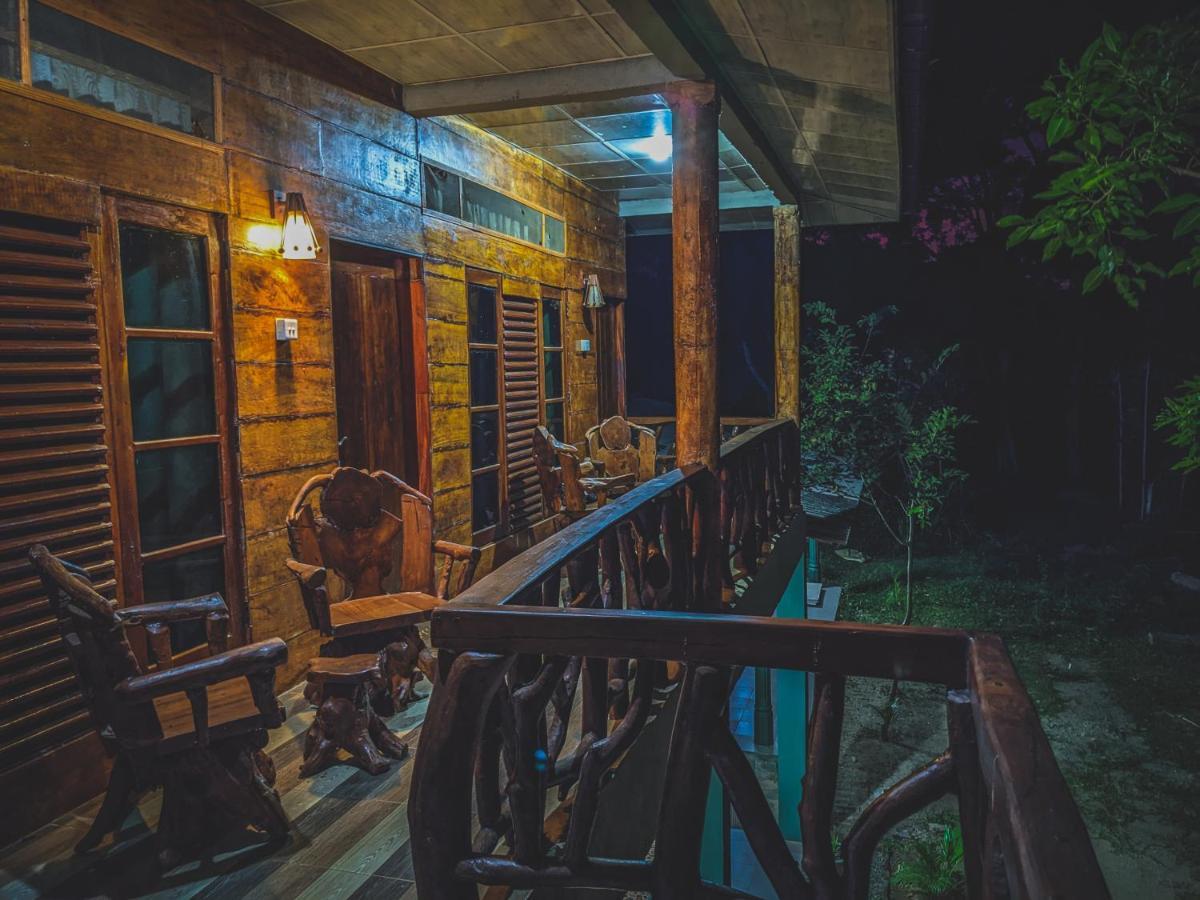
[287,467,480,704]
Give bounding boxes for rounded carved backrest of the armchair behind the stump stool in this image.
[287,467,433,628]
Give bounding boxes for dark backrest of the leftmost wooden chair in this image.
[29,544,143,733]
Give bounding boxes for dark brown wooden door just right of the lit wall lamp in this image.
[332,260,419,486]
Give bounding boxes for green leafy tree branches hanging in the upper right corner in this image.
[998,16,1200,306]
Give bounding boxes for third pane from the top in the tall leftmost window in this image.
[134,444,221,553]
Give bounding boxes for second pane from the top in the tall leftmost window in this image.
[130,337,217,440]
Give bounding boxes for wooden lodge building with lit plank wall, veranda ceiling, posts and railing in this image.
[0,0,1103,896]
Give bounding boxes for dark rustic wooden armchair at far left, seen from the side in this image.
[29,545,288,869]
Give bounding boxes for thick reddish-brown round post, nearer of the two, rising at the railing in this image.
[667,82,721,472]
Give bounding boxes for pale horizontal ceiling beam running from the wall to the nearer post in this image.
[404,56,679,118]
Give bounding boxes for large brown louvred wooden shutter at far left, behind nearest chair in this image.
[0,212,115,770]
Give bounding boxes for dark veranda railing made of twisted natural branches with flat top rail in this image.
[409,422,1108,900]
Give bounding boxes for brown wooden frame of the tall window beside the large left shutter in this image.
[101,196,245,659]
